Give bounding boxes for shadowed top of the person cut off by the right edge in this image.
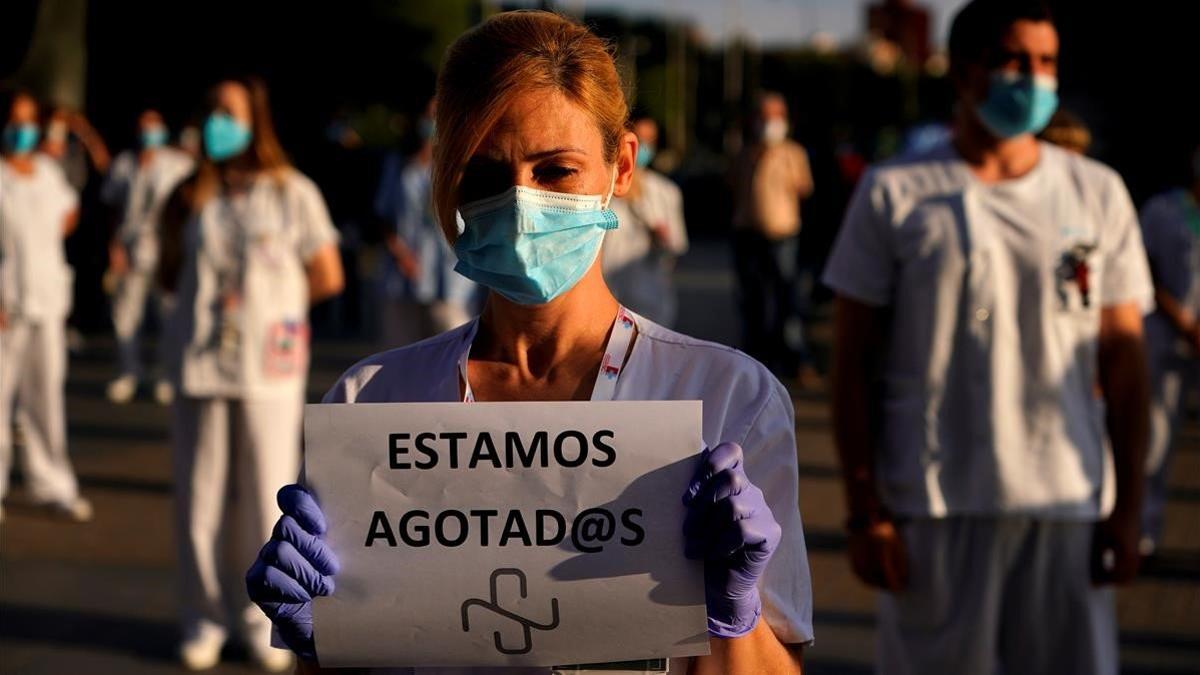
[1141,190,1200,354]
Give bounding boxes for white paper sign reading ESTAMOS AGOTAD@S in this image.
[305,401,708,667]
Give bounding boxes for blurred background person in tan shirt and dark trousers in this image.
[731,91,821,388]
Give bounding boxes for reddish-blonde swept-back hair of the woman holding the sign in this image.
[432,10,629,241]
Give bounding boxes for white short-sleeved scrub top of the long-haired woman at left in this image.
[168,169,337,399]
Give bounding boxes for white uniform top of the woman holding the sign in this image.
[309,312,812,675]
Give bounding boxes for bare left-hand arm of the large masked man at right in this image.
[833,295,908,591]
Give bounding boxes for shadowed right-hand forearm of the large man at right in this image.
[1100,335,1150,515]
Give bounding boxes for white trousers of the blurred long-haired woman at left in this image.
[172,396,304,646]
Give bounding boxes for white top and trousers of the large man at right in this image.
[824,143,1153,674]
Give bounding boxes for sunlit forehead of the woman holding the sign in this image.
[475,90,604,160]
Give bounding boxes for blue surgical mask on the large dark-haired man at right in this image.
[978,72,1058,138]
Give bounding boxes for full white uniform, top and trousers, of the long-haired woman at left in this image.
[167,169,337,645]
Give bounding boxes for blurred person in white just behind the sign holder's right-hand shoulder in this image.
[601,114,688,327]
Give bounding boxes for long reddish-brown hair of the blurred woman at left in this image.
[192,77,292,205]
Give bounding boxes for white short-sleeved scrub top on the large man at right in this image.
[824,143,1153,520]
